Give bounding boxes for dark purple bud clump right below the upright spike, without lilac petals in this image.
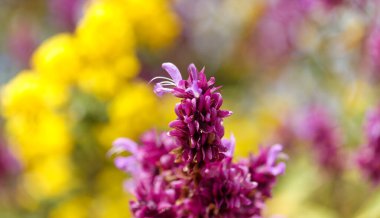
[194,158,263,218]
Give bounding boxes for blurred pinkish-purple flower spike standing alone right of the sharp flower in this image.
[300,106,343,172]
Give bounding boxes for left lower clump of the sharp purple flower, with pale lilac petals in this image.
[109,131,185,218]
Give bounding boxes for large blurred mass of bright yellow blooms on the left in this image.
[0,0,180,217]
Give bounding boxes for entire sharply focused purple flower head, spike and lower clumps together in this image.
[110,63,285,218]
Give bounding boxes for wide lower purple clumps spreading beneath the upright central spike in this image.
[111,131,285,218]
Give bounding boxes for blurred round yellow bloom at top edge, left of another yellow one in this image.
[76,1,135,61]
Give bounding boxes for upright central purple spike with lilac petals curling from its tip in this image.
[154,63,232,164]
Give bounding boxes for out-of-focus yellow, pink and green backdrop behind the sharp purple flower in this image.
[0,0,380,218]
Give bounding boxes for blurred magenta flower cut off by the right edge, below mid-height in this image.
[357,108,380,185]
